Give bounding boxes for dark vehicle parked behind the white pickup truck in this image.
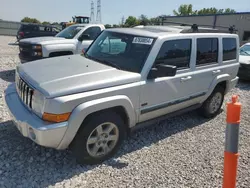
[16,24,60,41]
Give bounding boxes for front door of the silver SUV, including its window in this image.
[139,38,198,122]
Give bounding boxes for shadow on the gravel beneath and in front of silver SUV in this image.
[0,109,213,187]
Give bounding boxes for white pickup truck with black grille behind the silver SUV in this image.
[19,24,105,63]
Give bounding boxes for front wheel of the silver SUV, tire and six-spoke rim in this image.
[70,111,126,165]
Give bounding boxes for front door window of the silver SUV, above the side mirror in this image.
[155,39,192,69]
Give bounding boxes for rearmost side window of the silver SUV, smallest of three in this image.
[222,38,237,61]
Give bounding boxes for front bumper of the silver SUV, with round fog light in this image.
[4,84,68,149]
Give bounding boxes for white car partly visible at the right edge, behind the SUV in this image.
[238,43,250,80]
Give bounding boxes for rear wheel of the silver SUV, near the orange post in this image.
[199,86,225,118]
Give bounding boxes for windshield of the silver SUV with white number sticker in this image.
[85,31,154,73]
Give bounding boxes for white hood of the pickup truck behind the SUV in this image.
[20,37,76,45]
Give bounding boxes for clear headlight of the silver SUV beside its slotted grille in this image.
[32,90,45,117]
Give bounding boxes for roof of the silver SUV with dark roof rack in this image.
[108,25,237,38]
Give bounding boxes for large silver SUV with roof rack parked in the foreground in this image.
[4,26,239,164]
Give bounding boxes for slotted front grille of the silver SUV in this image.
[16,74,34,108]
